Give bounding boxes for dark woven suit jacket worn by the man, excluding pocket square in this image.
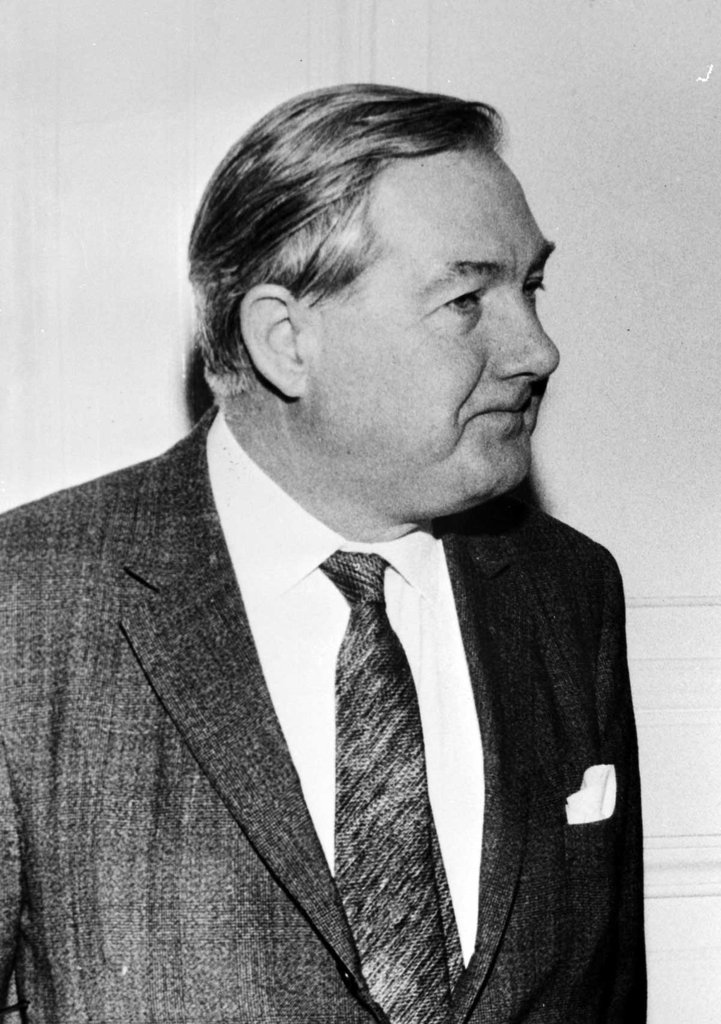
[0,411,644,1024]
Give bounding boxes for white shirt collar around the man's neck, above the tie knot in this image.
[202,414,442,602]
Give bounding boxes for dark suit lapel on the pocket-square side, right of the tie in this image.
[446,524,535,1021]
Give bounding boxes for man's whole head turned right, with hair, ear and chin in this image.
[192,86,558,540]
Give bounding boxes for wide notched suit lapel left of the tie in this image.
[122,415,361,982]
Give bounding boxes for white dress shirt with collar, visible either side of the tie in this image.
[208,415,484,963]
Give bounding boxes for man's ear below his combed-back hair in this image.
[241,285,309,398]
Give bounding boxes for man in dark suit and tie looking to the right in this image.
[0,86,645,1024]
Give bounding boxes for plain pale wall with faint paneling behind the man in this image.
[0,0,721,1024]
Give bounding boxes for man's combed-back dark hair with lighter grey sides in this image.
[189,85,502,396]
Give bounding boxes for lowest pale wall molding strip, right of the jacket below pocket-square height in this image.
[643,835,721,899]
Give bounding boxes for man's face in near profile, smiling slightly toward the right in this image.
[299,152,558,530]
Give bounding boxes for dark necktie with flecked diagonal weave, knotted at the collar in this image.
[321,551,451,1024]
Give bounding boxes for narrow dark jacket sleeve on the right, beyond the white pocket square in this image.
[597,556,646,1024]
